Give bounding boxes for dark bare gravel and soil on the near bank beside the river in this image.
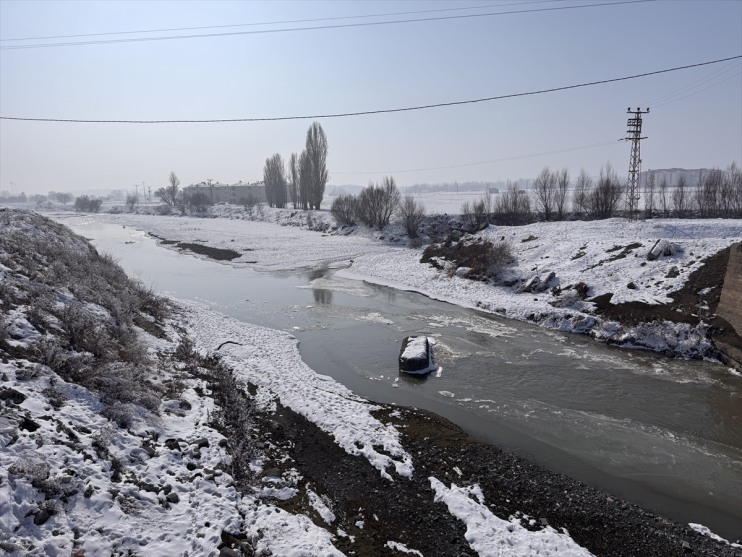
[231,398,742,557]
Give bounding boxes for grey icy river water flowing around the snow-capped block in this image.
[60,218,742,539]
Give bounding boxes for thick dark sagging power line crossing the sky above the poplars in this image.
[0,54,742,124]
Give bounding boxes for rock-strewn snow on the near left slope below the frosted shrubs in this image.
[0,344,342,557]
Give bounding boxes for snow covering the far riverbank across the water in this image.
[53,206,742,357]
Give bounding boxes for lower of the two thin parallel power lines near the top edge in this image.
[0,0,657,50]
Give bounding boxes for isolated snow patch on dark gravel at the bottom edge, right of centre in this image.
[429,476,592,557]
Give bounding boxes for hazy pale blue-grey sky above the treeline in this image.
[0,0,742,193]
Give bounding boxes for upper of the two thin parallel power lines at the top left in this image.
[0,0,568,42]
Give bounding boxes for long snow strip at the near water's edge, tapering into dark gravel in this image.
[183,302,413,479]
